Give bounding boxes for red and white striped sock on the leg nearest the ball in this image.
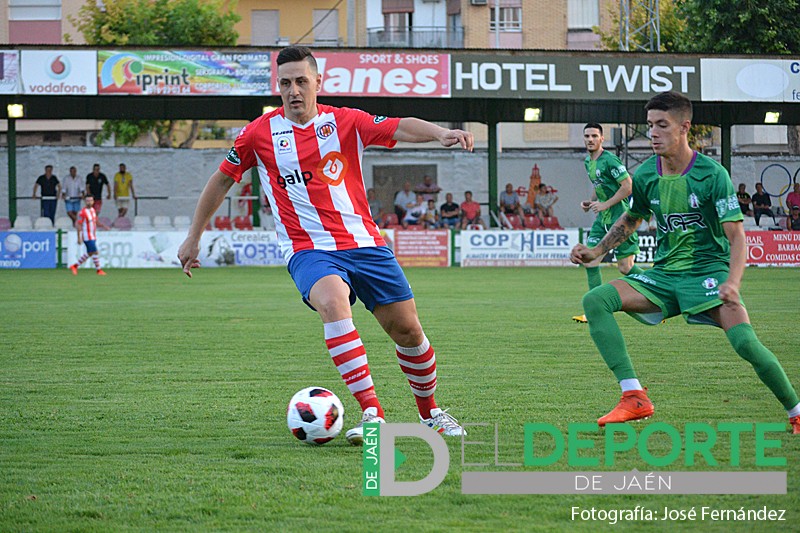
[323,318,384,418]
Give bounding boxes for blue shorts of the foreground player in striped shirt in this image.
[289,246,414,312]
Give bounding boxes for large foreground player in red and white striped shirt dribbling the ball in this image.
[178,46,473,445]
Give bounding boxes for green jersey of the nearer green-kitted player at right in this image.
[631,152,743,272]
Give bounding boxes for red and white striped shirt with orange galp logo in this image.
[219,104,400,263]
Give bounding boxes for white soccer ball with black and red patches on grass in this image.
[286,387,344,445]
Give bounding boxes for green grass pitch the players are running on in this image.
[0,268,800,531]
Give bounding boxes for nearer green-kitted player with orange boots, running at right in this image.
[571,92,800,434]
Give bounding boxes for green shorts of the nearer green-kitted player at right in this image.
[620,268,744,327]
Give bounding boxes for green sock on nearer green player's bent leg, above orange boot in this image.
[583,284,636,381]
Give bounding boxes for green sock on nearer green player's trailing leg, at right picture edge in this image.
[728,321,798,411]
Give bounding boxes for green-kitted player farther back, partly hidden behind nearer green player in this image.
[572,122,643,322]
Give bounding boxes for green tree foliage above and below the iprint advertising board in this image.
[70,0,241,148]
